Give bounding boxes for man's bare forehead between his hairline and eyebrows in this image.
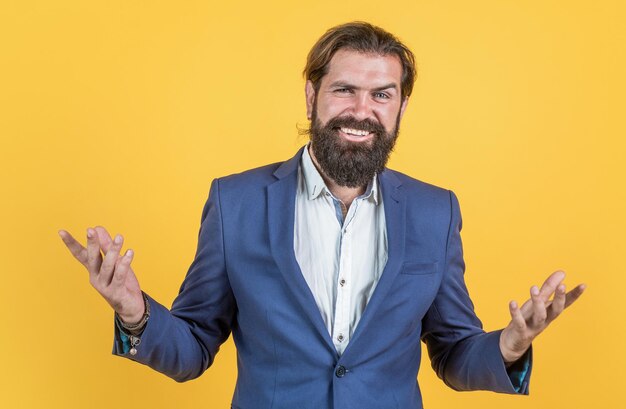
[322,49,402,90]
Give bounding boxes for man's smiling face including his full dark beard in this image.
[306,50,408,187]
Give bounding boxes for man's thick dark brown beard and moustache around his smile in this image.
[308,106,400,188]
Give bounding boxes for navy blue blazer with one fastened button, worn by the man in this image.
[113,149,530,409]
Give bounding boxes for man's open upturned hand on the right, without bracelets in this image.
[500,271,586,366]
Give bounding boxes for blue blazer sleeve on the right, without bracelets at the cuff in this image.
[422,192,532,394]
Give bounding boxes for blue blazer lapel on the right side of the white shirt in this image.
[344,170,406,350]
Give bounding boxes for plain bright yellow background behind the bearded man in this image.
[0,0,626,409]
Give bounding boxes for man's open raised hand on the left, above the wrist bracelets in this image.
[59,226,145,324]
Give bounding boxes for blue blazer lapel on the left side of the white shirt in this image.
[267,148,336,352]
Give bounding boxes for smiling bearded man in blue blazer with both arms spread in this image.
[60,23,584,409]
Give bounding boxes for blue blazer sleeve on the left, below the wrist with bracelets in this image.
[113,179,237,382]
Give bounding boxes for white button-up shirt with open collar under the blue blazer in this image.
[294,146,387,355]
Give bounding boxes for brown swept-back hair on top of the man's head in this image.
[302,21,417,99]
